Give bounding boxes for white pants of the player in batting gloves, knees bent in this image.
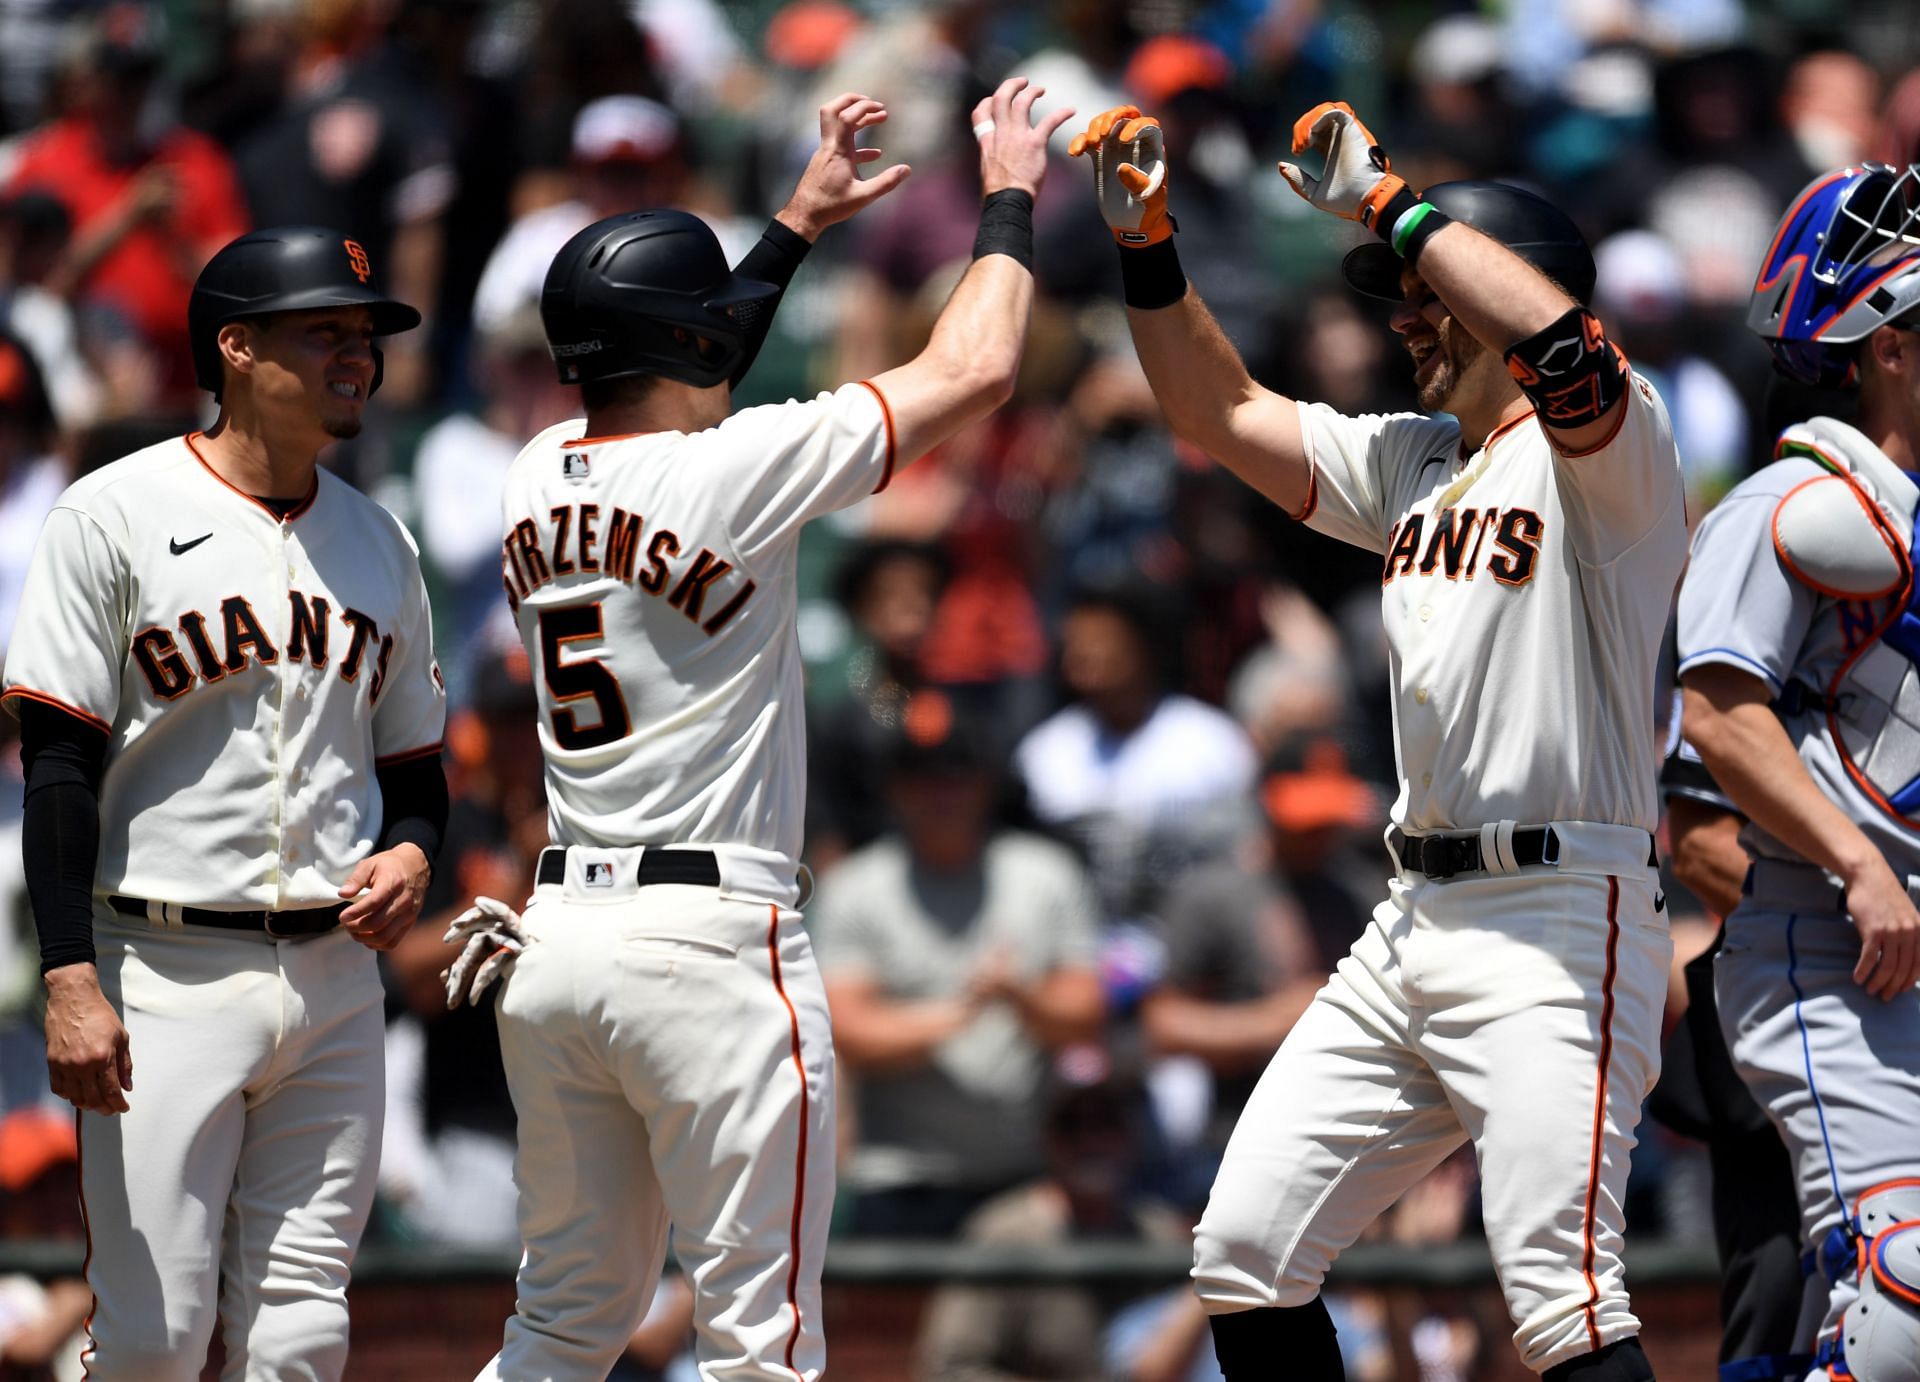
[1192,825,1672,1372]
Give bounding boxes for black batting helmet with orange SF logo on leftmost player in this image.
[186,226,420,397]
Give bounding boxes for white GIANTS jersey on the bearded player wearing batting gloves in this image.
[1298,374,1688,831]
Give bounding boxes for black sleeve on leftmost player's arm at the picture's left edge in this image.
[15,701,108,973]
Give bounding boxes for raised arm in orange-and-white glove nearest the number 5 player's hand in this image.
[1069,106,1309,512]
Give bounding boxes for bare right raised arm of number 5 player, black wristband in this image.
[872,77,1073,465]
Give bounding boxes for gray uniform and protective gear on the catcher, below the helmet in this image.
[1680,418,1920,1382]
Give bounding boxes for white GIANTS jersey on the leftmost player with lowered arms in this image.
[4,434,445,910]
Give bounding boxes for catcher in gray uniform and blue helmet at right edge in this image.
[1678,163,1920,1382]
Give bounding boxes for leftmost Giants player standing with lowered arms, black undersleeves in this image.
[4,226,447,1382]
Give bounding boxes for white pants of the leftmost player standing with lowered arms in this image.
[79,908,386,1382]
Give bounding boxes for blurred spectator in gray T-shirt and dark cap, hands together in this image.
[808,693,1106,1238]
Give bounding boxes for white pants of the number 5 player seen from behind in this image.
[480,863,833,1382]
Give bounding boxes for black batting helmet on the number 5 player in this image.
[540,211,780,388]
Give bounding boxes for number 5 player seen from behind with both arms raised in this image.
[449,79,1071,1382]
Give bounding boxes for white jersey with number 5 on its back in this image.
[501,384,893,875]
